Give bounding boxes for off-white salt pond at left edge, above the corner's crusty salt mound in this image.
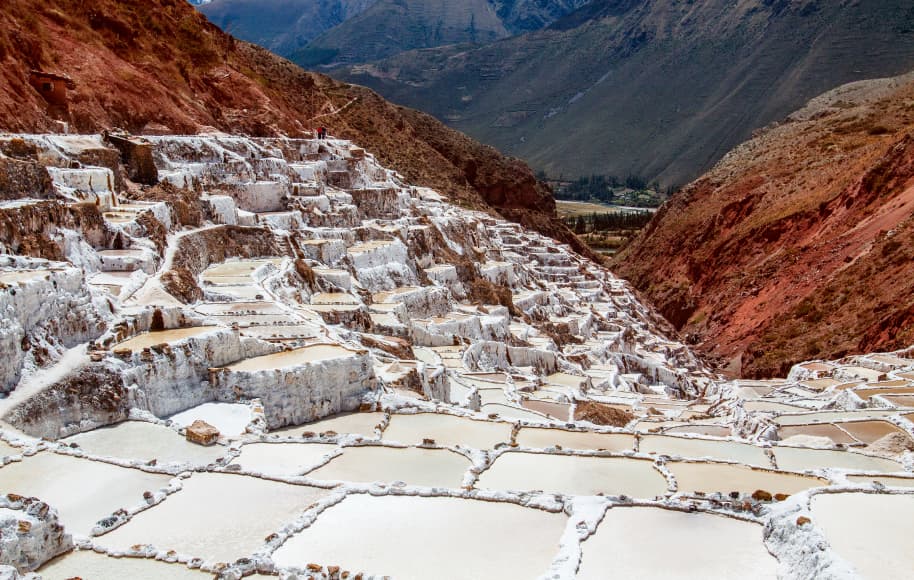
[0,451,171,535]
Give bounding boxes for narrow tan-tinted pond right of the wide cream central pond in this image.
[667,462,828,494]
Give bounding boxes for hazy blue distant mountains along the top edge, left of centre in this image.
[190,0,588,66]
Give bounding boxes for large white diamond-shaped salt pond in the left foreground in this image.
[97,473,328,562]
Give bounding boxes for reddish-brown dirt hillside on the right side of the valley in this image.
[616,75,914,377]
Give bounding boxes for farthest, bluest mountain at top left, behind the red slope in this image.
[198,0,375,56]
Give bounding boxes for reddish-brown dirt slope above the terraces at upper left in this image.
[0,0,573,255]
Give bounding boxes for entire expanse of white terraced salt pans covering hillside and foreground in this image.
[0,135,914,580]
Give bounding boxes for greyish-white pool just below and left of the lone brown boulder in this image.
[61,421,227,466]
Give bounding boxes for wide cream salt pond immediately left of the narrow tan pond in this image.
[476,452,668,498]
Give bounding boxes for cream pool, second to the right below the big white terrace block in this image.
[383,413,511,449]
